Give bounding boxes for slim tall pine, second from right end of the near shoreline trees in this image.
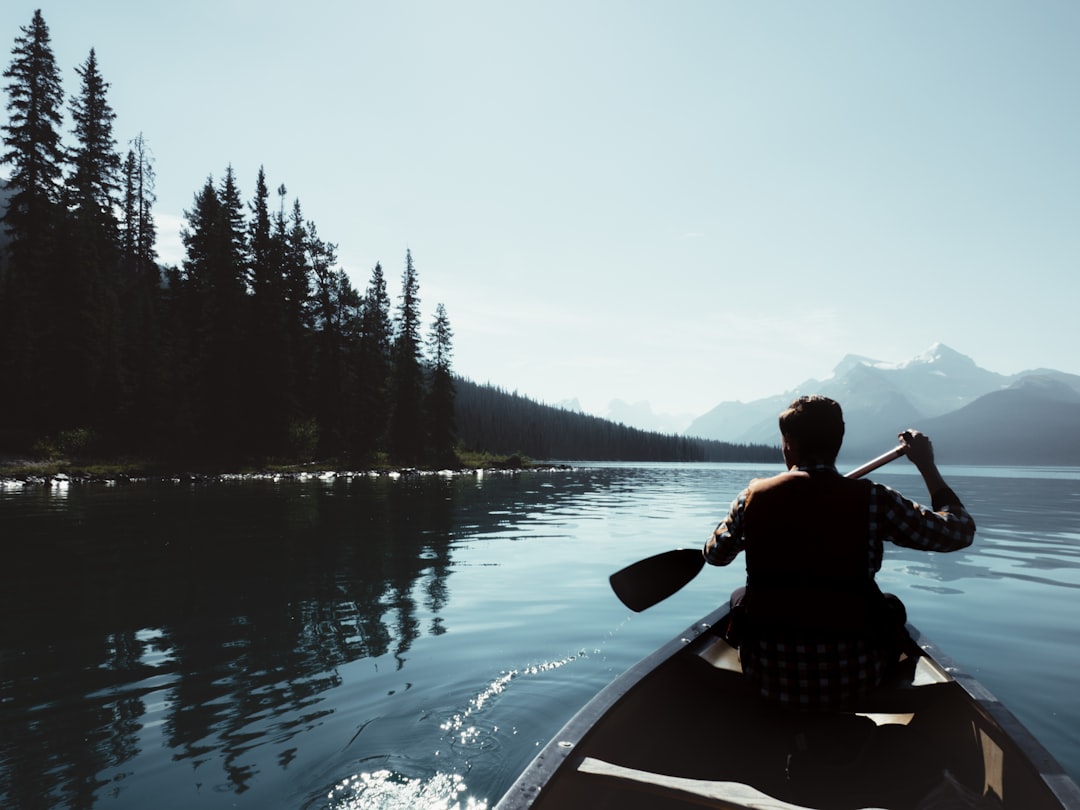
[390,251,424,464]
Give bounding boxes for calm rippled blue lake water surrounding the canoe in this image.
[0,461,1080,810]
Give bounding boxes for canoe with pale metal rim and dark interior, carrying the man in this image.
[496,607,1080,810]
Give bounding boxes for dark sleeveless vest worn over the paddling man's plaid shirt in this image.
[742,471,885,642]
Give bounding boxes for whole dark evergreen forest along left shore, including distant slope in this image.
[0,11,777,467]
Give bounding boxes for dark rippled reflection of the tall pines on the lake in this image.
[0,475,574,808]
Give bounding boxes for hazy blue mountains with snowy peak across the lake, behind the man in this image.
[686,343,1080,465]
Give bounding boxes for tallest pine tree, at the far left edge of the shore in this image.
[0,10,64,435]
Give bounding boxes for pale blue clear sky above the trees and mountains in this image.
[0,0,1080,427]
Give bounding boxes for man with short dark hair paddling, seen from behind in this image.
[704,395,975,711]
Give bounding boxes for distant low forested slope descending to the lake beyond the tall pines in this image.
[455,378,780,461]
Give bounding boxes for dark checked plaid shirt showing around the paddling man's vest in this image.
[705,465,975,708]
